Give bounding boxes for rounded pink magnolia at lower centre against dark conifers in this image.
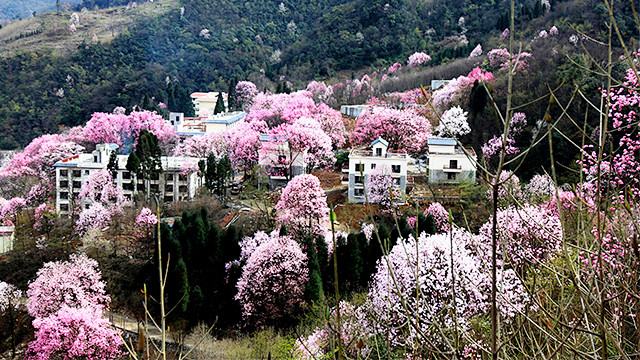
[235,236,309,328]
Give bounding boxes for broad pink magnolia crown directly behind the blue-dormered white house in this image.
[349,107,431,153]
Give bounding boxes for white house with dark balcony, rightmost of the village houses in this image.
[427,138,477,184]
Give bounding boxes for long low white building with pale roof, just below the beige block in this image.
[169,111,247,137]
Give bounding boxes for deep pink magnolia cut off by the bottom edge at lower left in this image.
[26,306,123,360]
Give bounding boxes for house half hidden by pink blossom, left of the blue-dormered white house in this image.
[258,134,307,181]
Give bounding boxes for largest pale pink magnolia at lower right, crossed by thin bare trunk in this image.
[367,230,530,355]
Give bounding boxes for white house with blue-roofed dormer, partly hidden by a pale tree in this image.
[343,138,409,203]
